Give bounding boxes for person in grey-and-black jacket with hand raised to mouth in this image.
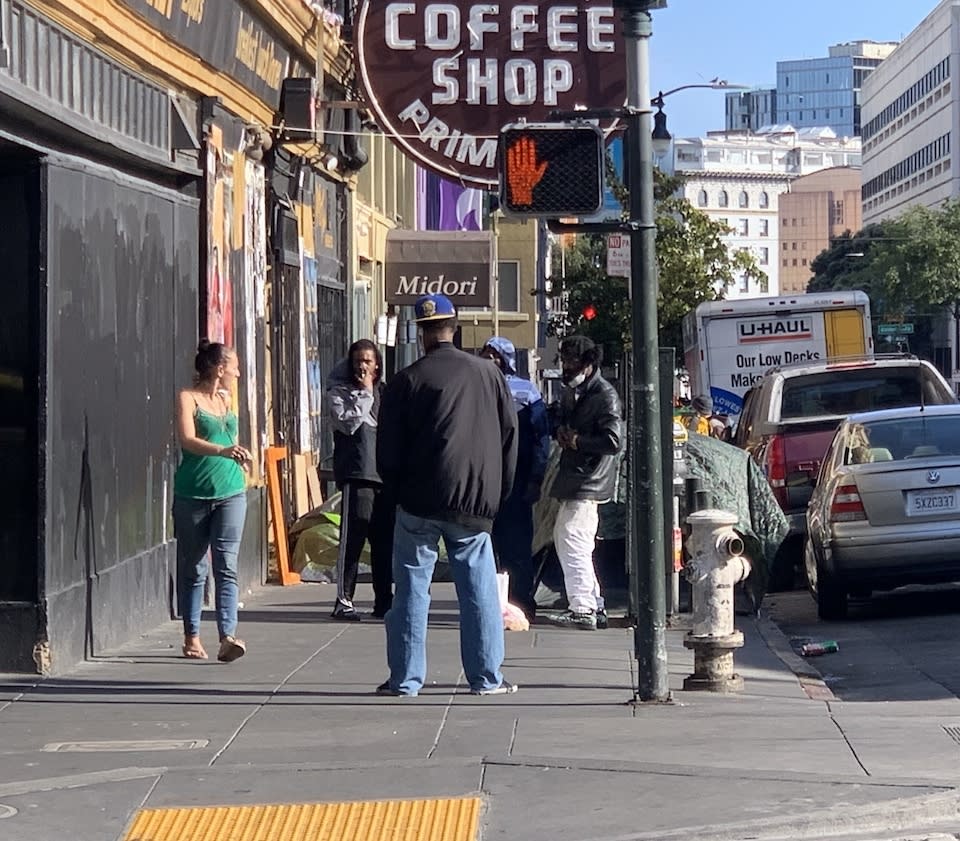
[327,339,395,622]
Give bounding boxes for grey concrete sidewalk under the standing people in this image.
[0,584,960,841]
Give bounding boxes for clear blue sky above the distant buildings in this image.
[650,0,937,137]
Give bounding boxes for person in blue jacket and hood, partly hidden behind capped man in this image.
[480,336,550,619]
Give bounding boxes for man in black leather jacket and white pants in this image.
[550,336,623,631]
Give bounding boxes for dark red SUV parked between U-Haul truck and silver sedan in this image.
[733,354,957,589]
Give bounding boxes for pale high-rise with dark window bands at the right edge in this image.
[862,0,960,225]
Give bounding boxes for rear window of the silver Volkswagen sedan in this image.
[843,415,960,464]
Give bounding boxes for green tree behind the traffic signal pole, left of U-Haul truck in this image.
[551,167,766,359]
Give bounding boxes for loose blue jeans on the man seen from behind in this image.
[385,508,503,695]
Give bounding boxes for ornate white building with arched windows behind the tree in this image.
[671,128,864,300]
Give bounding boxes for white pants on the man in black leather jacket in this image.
[553,499,603,613]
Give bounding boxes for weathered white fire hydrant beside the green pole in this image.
[683,509,750,692]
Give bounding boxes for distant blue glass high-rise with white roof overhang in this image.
[776,41,897,137]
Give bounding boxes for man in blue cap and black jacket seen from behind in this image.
[376,295,517,697]
